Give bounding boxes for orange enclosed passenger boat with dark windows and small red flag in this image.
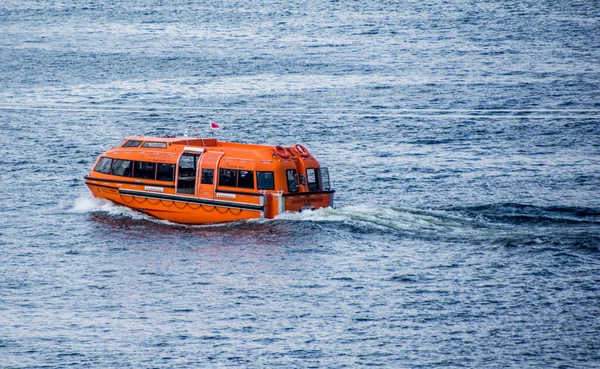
[85,136,335,224]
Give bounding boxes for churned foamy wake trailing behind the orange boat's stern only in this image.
[277,204,600,250]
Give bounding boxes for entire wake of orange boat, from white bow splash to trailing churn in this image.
[70,194,600,250]
